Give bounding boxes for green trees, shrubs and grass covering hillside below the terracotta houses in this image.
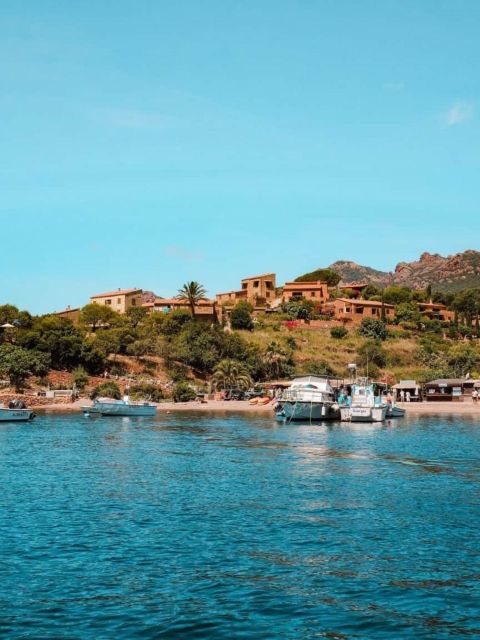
[0,283,480,400]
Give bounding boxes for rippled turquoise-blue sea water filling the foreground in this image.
[0,414,480,640]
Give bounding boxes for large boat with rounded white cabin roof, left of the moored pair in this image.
[275,376,340,422]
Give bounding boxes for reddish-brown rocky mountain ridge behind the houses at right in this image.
[329,249,480,291]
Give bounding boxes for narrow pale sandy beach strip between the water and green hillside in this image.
[33,399,480,419]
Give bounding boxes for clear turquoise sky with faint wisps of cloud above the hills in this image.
[0,0,480,313]
